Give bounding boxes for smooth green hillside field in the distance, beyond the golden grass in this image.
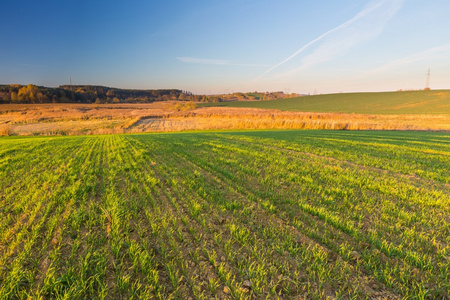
[204,90,450,114]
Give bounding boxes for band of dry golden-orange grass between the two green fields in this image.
[0,102,450,135]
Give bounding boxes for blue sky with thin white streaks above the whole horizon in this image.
[0,0,450,94]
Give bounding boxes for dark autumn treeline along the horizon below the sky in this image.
[0,84,299,104]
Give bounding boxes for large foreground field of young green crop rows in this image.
[0,130,450,299]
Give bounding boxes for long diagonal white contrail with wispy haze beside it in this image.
[256,0,406,80]
